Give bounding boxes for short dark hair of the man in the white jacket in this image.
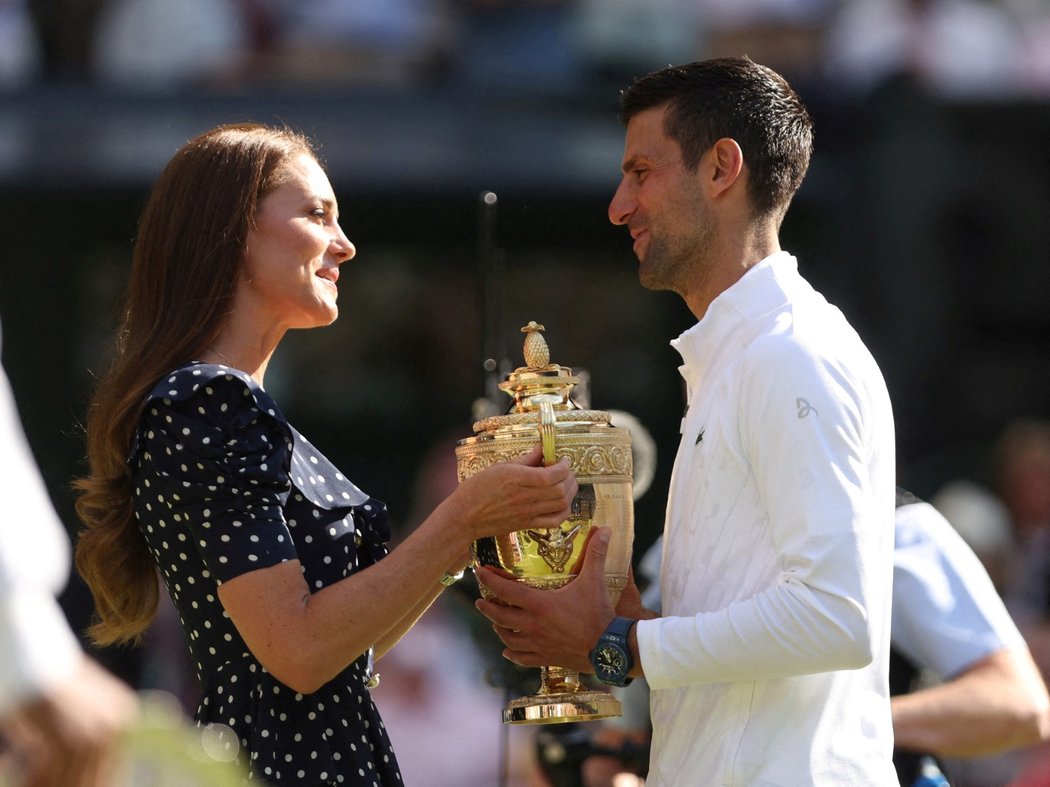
[620,58,813,221]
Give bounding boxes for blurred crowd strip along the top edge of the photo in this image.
[0,0,1050,99]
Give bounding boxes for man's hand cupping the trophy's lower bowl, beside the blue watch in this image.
[475,528,615,673]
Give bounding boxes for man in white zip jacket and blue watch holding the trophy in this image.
[478,59,897,787]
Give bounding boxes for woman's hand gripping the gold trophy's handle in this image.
[445,444,579,540]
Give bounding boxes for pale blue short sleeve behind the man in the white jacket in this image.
[891,503,1024,679]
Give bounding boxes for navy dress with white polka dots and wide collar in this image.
[131,362,401,787]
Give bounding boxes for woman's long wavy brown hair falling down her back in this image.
[74,124,316,645]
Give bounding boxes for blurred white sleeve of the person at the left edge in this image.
[0,360,81,718]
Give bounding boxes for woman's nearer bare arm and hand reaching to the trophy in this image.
[218,447,576,694]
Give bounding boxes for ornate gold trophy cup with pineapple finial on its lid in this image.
[456,322,634,724]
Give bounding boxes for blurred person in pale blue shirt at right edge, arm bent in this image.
[890,492,1050,785]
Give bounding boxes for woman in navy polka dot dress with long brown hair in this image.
[77,125,576,785]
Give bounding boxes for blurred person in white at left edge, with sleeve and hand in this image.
[0,325,138,787]
